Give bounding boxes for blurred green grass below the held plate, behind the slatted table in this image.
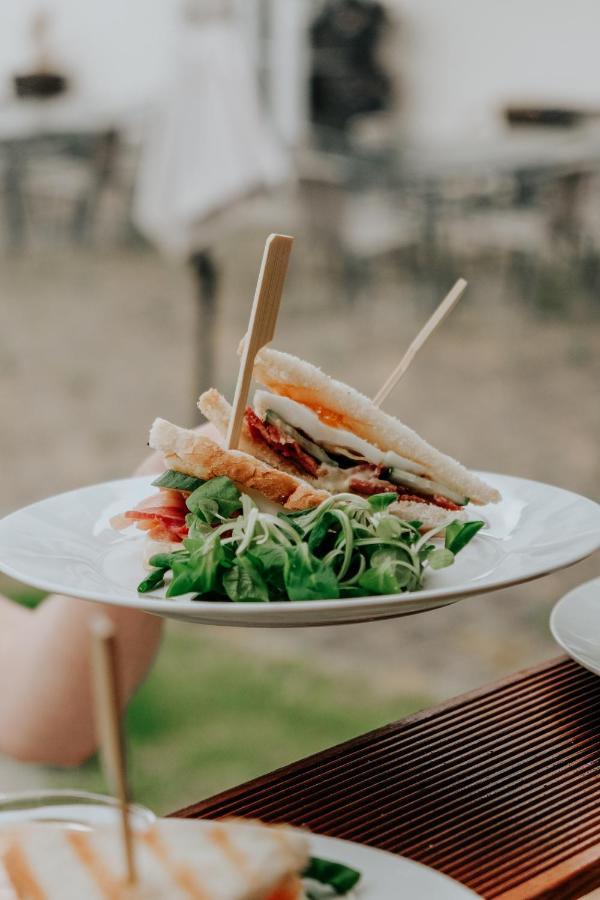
[2,586,428,813]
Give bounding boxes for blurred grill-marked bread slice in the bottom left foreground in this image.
[0,819,308,900]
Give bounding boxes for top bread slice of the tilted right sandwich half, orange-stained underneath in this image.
[254,347,500,504]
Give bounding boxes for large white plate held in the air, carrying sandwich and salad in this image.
[0,474,600,627]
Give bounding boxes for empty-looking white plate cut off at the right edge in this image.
[550,578,600,675]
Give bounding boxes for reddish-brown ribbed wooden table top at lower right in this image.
[175,658,600,900]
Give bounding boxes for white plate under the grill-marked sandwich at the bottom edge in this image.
[310,834,479,900]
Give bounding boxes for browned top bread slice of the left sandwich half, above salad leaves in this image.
[149,419,331,510]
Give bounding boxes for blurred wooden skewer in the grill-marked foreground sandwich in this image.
[91,615,137,884]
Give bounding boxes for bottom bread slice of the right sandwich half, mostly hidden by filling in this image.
[198,388,467,528]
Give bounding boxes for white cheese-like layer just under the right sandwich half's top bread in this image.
[254,391,427,478]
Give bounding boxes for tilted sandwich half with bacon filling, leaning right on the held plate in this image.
[198,348,500,527]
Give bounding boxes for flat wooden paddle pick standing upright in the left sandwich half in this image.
[226,234,294,450]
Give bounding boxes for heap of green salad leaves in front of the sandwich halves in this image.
[138,471,484,603]
